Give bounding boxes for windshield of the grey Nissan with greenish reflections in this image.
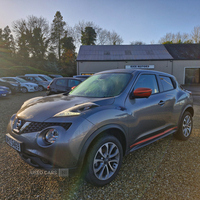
[69,73,131,98]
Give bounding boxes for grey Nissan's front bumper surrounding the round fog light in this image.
[6,115,93,170]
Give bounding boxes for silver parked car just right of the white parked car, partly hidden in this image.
[18,75,49,91]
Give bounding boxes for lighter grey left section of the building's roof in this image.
[77,44,173,61]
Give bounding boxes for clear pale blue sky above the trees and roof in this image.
[0,0,200,44]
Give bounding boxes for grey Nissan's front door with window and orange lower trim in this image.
[125,73,176,148]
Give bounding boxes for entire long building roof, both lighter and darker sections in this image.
[77,44,200,61]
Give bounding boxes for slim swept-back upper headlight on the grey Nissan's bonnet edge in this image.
[53,102,99,117]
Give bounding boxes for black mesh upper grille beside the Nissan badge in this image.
[21,122,71,133]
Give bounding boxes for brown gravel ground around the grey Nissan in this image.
[0,92,200,200]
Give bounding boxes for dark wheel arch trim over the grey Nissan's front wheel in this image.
[78,124,127,170]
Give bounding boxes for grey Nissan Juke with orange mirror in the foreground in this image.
[6,69,194,186]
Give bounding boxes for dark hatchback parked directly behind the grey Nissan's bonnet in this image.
[47,77,82,95]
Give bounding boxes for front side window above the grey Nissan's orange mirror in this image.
[134,74,159,94]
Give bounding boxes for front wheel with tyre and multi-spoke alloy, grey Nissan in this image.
[85,136,123,186]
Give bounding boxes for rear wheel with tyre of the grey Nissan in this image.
[174,111,193,141]
